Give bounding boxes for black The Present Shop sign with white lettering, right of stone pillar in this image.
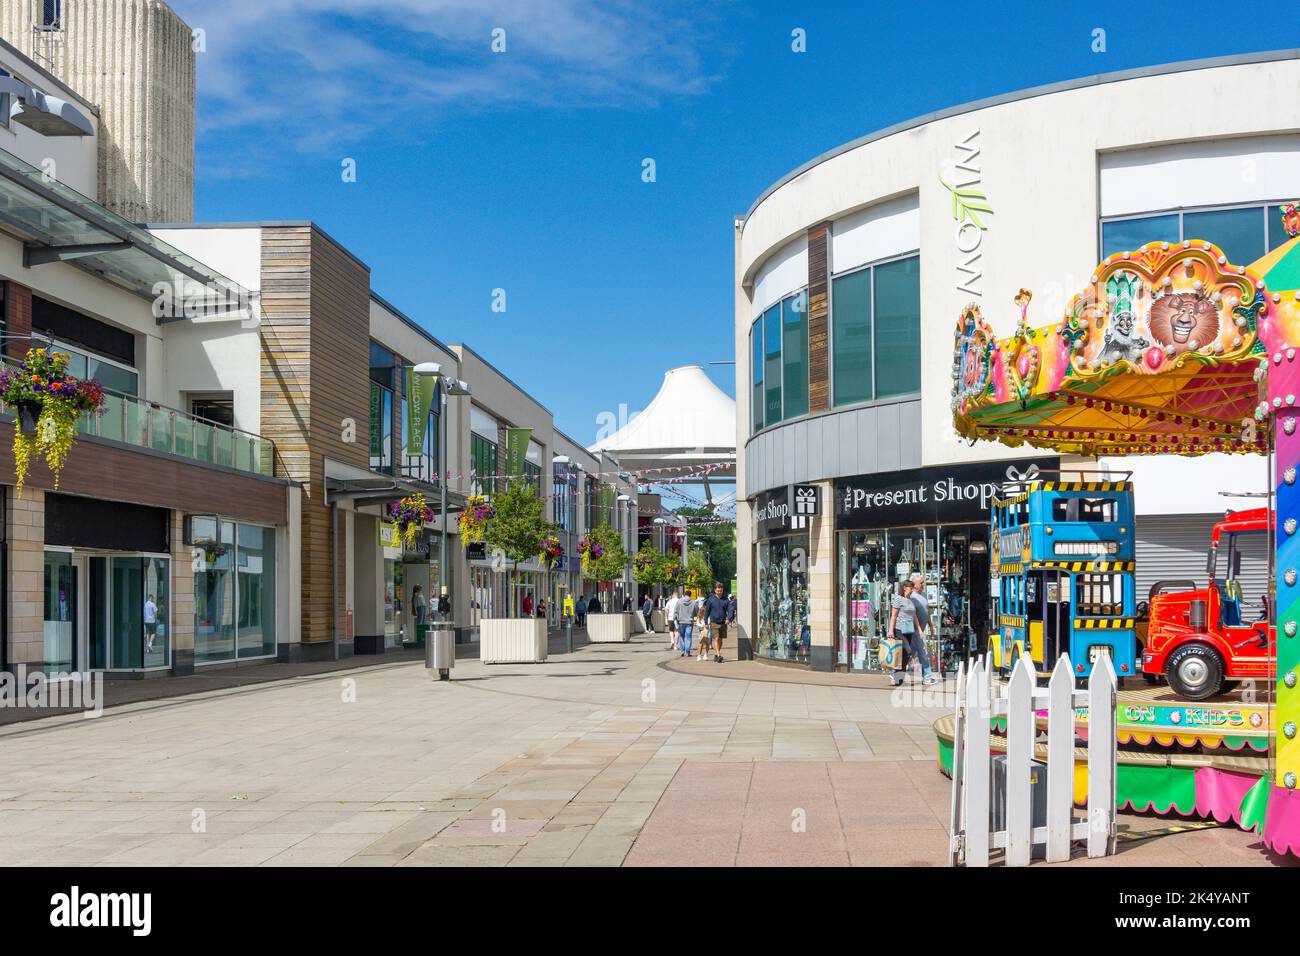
[835,458,1061,528]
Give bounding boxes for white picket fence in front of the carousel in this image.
[949,654,1117,866]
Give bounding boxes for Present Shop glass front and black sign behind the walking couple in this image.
[835,458,1060,671]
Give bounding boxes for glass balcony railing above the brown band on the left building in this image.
[5,363,276,477]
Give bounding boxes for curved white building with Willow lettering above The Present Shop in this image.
[735,51,1300,671]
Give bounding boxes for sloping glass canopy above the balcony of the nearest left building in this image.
[0,141,255,324]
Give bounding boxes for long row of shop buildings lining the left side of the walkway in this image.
[0,11,650,676]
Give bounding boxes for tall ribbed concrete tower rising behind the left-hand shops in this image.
[0,0,195,222]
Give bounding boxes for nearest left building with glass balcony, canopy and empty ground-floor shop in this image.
[0,52,302,676]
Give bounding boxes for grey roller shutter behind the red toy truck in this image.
[1135,512,1269,611]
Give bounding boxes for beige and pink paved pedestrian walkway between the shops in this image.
[0,637,1284,866]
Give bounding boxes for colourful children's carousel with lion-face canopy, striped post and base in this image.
[935,203,1300,856]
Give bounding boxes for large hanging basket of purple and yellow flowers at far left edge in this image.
[0,349,104,497]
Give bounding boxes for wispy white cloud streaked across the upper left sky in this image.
[172,0,720,167]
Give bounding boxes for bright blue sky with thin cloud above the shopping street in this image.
[172,0,1300,442]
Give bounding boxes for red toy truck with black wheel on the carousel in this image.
[1141,507,1277,700]
